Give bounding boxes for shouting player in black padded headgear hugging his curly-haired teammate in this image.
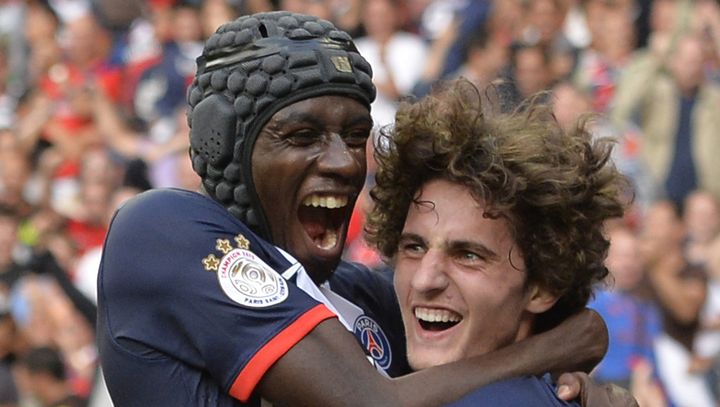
[98,12,620,406]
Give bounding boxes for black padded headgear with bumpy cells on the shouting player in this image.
[188,11,375,241]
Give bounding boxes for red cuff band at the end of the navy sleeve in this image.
[230,304,336,402]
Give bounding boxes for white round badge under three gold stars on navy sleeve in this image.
[202,235,288,308]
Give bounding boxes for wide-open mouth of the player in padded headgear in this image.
[298,194,348,250]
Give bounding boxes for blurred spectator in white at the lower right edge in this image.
[640,201,717,407]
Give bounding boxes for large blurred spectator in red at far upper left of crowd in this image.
[19,10,122,220]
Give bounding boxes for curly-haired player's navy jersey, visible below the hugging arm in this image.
[448,375,580,407]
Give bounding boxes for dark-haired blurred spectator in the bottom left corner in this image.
[20,347,84,407]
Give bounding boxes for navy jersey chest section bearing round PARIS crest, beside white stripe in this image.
[330,262,410,377]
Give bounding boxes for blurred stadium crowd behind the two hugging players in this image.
[0,0,720,407]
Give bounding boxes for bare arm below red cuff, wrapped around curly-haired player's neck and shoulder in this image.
[257,311,607,406]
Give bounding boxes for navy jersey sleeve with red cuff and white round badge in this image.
[98,191,334,401]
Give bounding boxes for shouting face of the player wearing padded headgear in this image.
[253,96,372,282]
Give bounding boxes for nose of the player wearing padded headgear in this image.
[317,133,365,179]
